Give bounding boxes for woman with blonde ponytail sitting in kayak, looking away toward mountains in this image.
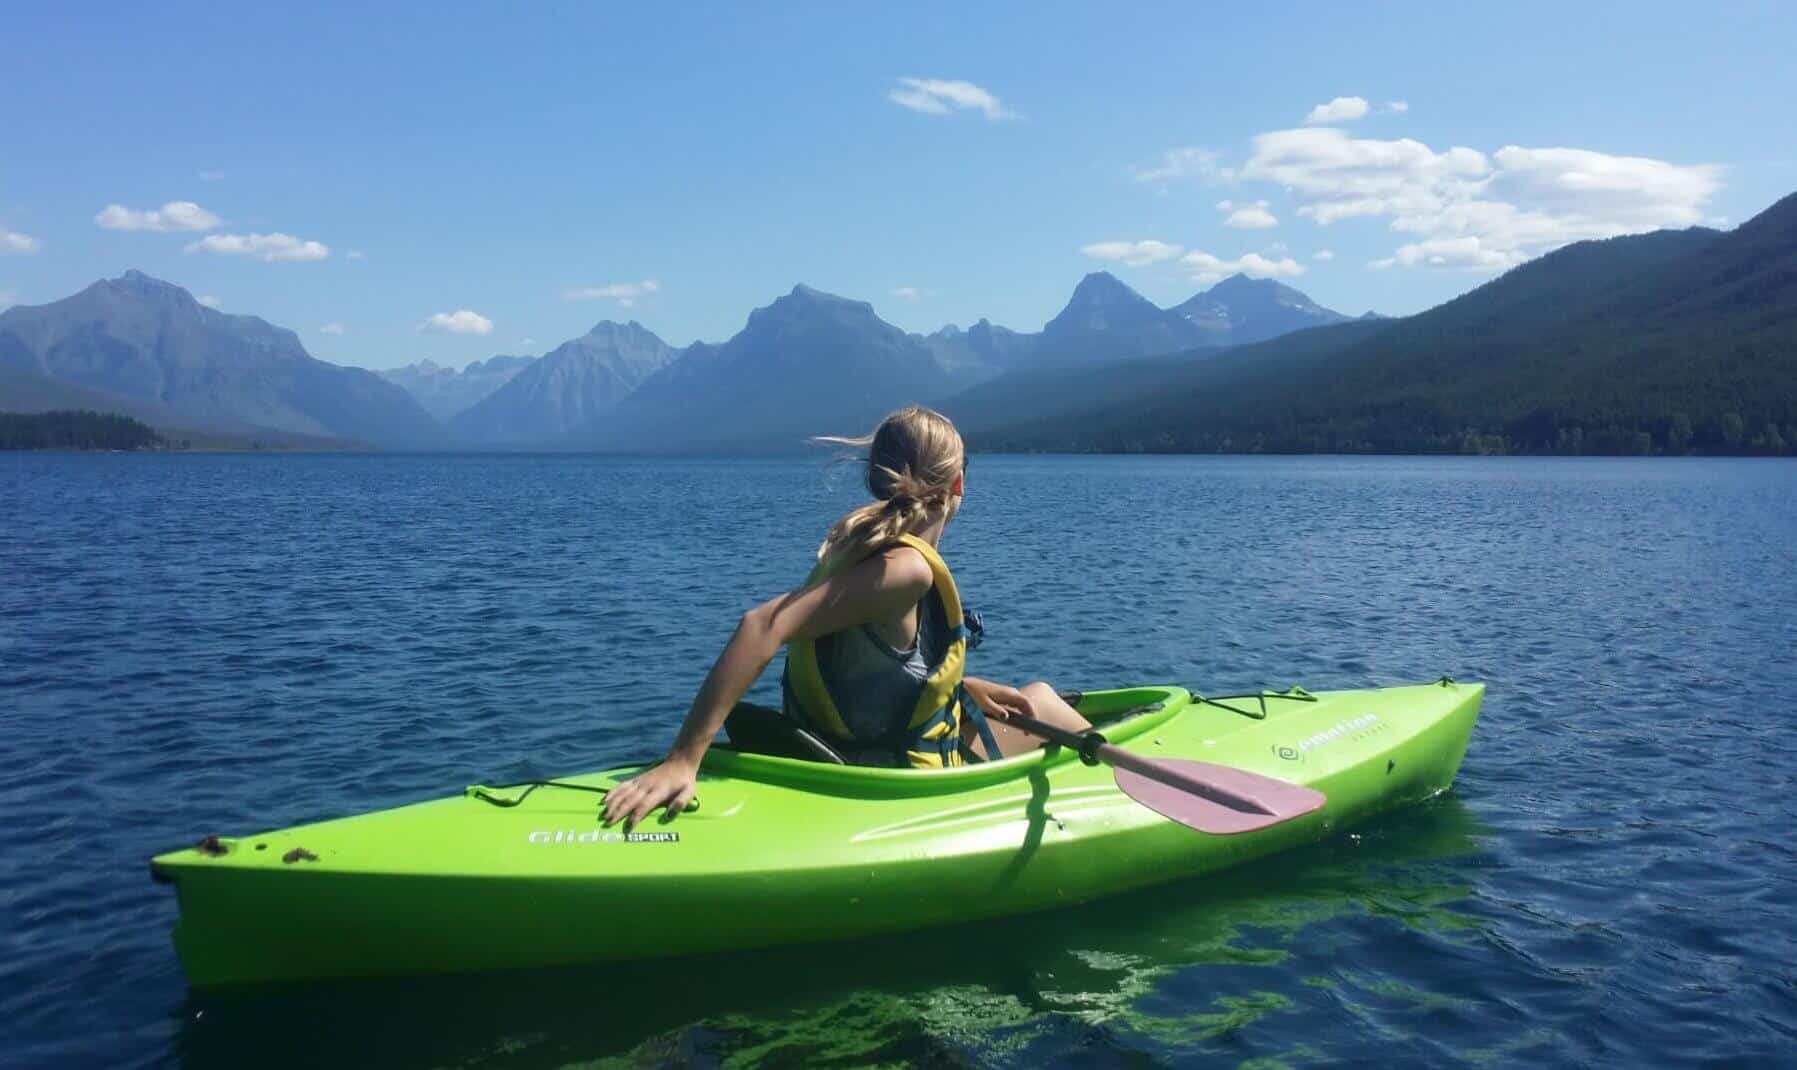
[604,406,1091,825]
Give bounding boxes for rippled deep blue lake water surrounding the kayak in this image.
[0,453,1797,1066]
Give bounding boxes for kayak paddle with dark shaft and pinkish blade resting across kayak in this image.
[1005,714,1328,836]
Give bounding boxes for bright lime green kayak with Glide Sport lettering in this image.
[151,680,1484,987]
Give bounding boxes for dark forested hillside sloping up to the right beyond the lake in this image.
[978,196,1797,455]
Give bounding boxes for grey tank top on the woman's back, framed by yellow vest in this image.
[785,593,949,766]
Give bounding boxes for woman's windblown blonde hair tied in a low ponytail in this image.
[812,405,967,563]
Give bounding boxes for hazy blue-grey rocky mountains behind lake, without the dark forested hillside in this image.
[0,272,1344,450]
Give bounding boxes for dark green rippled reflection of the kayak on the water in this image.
[181,795,1481,1066]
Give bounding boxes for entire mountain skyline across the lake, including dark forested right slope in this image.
[0,196,1797,453]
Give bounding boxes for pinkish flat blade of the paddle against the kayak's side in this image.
[1114,759,1328,836]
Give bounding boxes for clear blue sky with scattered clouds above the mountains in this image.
[0,2,1797,367]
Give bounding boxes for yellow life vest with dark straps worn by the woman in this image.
[782,534,996,770]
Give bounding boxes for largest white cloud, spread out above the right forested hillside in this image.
[1242,128,1722,270]
